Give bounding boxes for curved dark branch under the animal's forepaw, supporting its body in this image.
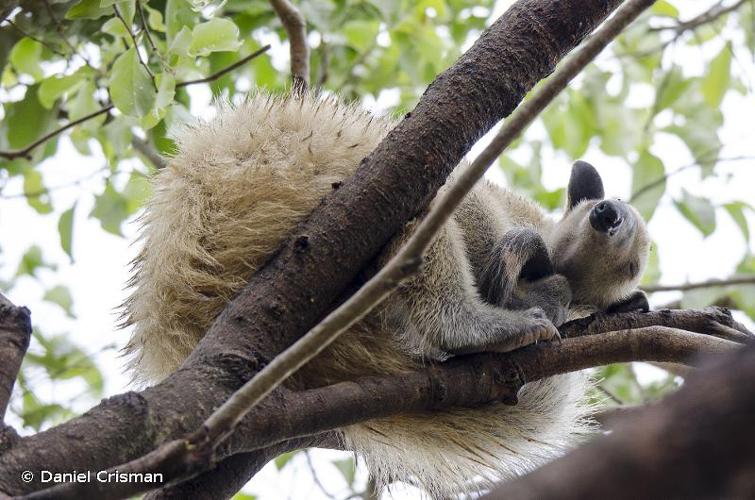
[32,326,738,499]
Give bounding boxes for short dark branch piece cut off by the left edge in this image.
[0,294,31,422]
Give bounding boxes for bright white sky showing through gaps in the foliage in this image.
[0,2,755,498]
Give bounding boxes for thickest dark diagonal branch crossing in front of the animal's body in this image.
[0,0,644,493]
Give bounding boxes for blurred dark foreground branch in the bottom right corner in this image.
[485,346,755,500]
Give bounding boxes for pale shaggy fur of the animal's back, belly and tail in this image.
[125,93,588,497]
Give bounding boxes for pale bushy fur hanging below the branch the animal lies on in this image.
[343,373,592,498]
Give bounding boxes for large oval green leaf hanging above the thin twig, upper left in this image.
[110,48,157,118]
